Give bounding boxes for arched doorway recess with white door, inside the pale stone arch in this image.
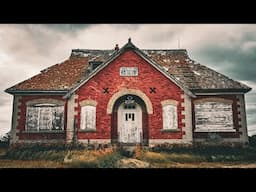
[111,94,148,145]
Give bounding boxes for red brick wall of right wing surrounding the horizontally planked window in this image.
[192,95,242,138]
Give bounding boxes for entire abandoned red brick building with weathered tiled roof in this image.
[6,39,251,145]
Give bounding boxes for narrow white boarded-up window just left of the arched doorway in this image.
[80,105,96,130]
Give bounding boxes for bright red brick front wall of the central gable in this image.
[75,51,185,139]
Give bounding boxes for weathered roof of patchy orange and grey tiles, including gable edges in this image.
[5,39,251,97]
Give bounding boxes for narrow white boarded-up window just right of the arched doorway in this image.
[163,105,178,130]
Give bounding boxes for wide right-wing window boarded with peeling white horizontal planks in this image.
[195,101,234,132]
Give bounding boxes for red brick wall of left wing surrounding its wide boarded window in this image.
[17,95,67,140]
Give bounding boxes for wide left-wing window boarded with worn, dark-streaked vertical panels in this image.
[26,104,64,131]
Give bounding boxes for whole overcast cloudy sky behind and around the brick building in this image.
[0,24,256,135]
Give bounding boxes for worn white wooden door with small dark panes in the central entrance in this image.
[118,104,142,143]
